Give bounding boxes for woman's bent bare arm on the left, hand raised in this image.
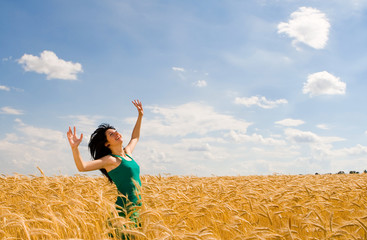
[67,127,106,172]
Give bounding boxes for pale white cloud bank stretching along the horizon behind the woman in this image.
[0,103,367,176]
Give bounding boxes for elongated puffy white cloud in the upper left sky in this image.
[18,50,83,80]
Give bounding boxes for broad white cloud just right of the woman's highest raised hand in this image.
[138,102,251,136]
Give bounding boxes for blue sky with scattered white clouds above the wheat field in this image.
[0,0,367,176]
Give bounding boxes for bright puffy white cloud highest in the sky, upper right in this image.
[278,7,330,49]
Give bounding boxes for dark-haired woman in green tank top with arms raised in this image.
[67,100,144,225]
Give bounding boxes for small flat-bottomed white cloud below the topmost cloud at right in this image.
[303,71,346,97]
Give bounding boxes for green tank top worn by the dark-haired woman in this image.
[108,154,141,209]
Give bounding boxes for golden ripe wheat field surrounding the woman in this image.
[0,170,367,240]
